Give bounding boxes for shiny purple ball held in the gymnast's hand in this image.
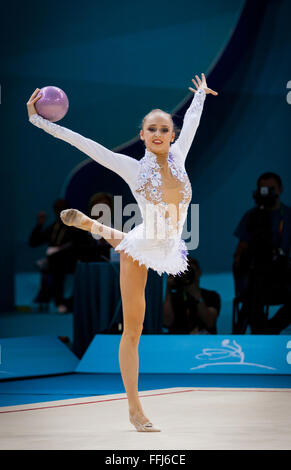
[35,86,69,122]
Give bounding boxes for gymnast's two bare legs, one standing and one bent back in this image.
[61,209,159,431]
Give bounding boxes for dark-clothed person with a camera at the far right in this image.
[233,172,291,334]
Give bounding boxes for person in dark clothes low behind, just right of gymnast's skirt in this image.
[164,257,221,334]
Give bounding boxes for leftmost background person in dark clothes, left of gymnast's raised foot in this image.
[29,199,78,313]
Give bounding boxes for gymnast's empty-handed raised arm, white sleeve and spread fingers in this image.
[173,73,218,163]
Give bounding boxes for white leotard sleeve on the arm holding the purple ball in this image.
[29,114,139,185]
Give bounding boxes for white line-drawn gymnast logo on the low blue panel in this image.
[190,339,276,370]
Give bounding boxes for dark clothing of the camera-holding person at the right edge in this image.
[234,202,291,334]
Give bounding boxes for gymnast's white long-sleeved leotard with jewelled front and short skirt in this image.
[29,89,206,275]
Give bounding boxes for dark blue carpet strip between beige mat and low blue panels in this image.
[0,374,291,406]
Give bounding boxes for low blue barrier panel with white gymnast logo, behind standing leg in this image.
[76,335,291,375]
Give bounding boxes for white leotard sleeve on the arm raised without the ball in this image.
[173,89,206,163]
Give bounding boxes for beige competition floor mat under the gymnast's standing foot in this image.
[0,387,291,450]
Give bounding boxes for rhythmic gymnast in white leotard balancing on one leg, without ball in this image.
[27,74,218,432]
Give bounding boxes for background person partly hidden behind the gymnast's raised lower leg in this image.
[76,192,113,263]
